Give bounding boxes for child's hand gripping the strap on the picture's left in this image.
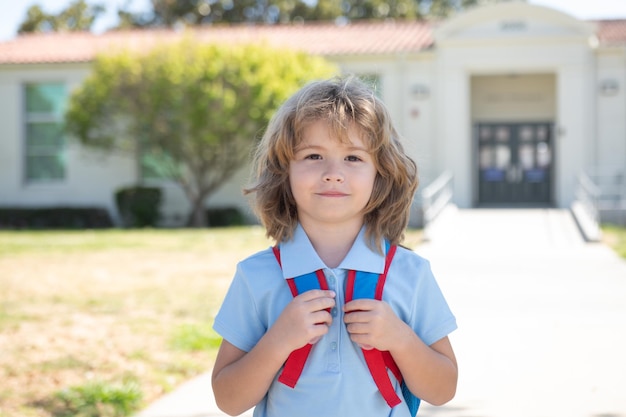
[270,290,335,352]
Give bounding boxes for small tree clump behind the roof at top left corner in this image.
[17,0,105,33]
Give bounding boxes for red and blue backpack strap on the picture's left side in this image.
[272,246,328,388]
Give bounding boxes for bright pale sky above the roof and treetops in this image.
[0,0,626,41]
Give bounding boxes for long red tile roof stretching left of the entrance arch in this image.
[0,22,433,64]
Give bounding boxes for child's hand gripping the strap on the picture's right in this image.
[343,299,412,351]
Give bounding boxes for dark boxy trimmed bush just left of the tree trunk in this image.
[115,186,162,227]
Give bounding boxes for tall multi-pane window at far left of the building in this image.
[24,83,67,182]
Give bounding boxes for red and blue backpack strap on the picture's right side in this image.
[346,245,402,407]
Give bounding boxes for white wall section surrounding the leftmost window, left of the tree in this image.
[0,65,135,221]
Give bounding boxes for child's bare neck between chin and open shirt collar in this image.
[302,218,363,268]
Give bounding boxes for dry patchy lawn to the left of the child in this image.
[0,226,421,417]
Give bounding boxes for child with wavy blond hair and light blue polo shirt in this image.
[213,78,457,417]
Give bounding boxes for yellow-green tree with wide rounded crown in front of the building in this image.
[66,39,337,226]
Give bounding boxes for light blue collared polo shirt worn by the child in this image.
[214,226,457,417]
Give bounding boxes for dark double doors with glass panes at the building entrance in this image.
[474,122,554,205]
